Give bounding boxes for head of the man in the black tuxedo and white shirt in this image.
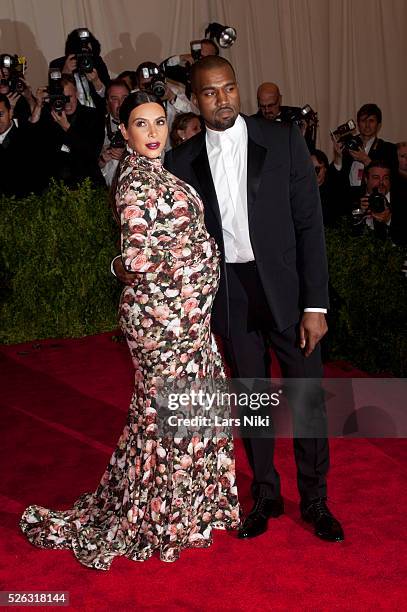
[192,65,240,131]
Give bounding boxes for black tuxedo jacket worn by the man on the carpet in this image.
[165,115,328,337]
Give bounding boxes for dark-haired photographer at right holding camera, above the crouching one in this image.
[331,104,397,209]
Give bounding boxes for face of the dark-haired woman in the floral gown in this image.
[120,102,168,159]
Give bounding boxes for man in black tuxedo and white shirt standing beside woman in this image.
[165,56,344,541]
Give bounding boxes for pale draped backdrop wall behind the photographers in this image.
[0,0,407,156]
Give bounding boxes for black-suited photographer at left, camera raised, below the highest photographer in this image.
[30,75,105,187]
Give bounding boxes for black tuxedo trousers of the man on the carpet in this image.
[224,262,329,502]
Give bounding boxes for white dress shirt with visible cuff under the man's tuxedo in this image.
[206,115,327,313]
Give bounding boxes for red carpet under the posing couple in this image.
[0,334,407,611]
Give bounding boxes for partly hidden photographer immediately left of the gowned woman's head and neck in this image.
[99,79,130,187]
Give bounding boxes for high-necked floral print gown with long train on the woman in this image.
[20,153,239,570]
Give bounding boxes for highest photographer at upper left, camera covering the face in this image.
[49,28,110,114]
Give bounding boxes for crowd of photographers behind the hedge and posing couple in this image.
[0,29,407,246]
